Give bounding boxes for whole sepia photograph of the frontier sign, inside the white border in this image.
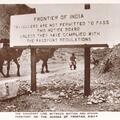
[0,4,120,115]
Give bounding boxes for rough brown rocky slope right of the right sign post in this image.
[92,44,120,79]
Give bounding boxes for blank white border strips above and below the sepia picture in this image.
[0,0,120,120]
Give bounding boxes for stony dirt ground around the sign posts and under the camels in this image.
[0,48,120,112]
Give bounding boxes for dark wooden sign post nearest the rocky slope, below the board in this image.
[84,46,90,96]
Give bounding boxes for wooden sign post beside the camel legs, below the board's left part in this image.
[31,48,36,92]
